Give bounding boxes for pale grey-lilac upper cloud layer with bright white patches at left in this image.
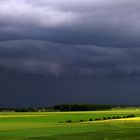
[0,0,140,47]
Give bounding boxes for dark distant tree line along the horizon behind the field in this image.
[0,104,140,112]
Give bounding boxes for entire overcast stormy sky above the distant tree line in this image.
[0,0,140,107]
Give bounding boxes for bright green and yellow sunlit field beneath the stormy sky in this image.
[0,108,140,140]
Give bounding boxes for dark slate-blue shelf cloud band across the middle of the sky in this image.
[0,40,140,76]
